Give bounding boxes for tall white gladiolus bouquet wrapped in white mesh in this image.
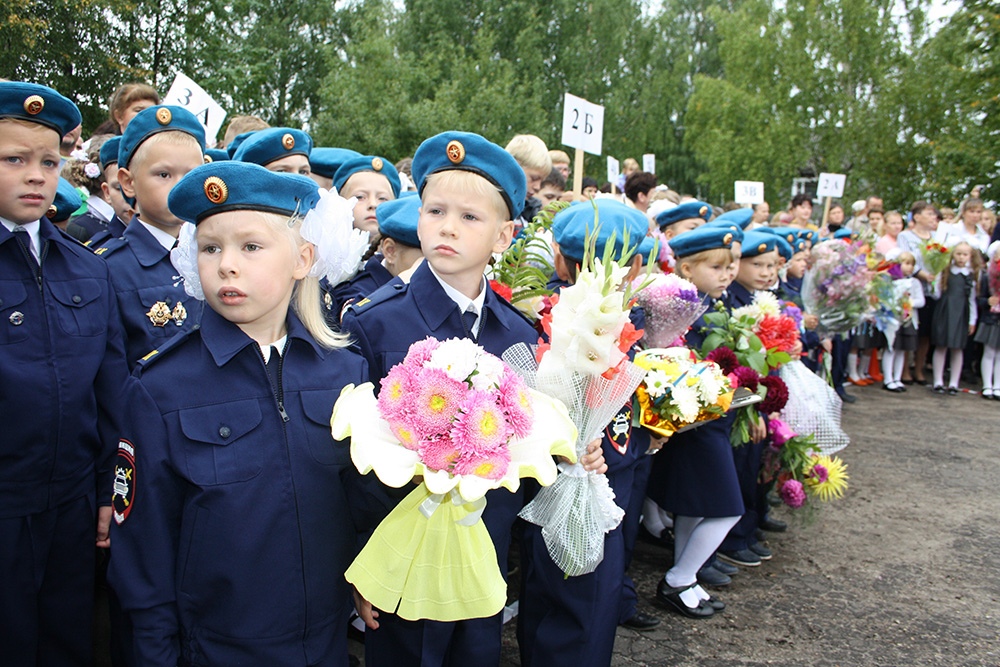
[503,228,645,576]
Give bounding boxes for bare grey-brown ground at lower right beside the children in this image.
[503,385,1000,667]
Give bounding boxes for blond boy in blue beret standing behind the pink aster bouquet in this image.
[338,132,604,667]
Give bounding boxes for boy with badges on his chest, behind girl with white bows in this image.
[95,106,205,368]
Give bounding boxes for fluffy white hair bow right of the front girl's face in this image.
[299,189,369,286]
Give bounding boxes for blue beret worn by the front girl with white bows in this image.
[166,160,319,224]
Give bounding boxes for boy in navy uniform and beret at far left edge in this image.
[0,82,128,665]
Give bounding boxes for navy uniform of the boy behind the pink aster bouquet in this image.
[341,262,538,667]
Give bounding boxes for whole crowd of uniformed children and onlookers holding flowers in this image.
[0,82,1000,666]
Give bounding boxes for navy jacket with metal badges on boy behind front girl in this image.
[96,217,205,368]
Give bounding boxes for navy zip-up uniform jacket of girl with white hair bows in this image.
[108,309,368,667]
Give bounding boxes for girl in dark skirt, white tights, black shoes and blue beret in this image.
[647,226,746,618]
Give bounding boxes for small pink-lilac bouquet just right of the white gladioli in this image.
[638,273,708,348]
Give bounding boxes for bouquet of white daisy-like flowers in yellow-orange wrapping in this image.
[635,347,733,438]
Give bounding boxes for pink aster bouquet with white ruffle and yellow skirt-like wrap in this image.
[330,338,577,621]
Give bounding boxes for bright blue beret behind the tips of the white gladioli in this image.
[552,199,655,261]
